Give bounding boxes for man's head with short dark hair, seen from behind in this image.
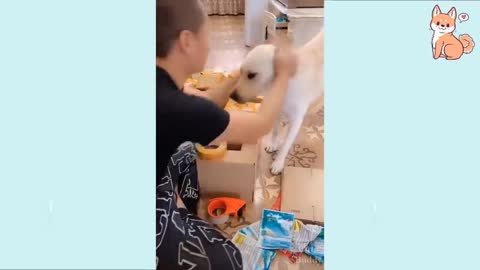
[156,0,209,74]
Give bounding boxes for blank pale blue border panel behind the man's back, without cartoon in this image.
[0,0,155,269]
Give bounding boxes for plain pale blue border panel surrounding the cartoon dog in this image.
[325,1,480,270]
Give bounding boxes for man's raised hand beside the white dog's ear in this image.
[274,40,298,78]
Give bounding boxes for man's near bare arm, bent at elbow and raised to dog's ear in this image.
[213,49,297,144]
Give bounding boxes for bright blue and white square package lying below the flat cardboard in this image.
[259,209,295,250]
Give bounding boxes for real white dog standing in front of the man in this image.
[232,31,324,174]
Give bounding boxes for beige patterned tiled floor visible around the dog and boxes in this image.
[200,16,324,270]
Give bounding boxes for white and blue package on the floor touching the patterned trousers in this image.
[232,231,277,270]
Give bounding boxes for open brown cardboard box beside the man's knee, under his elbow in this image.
[197,144,258,203]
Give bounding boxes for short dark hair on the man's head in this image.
[157,0,205,58]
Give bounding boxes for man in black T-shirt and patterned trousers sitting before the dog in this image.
[156,0,297,270]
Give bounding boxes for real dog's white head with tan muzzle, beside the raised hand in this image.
[231,44,275,103]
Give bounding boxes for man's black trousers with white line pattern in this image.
[156,142,243,270]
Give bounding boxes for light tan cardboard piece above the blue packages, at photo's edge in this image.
[280,167,324,223]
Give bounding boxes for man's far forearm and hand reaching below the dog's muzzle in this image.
[184,71,240,108]
